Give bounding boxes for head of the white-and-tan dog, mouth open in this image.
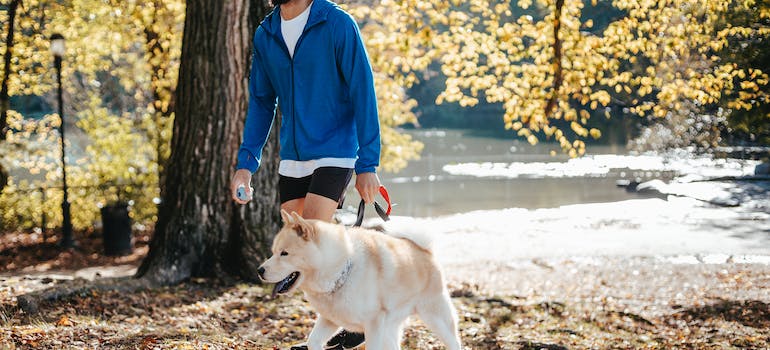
[258,210,322,296]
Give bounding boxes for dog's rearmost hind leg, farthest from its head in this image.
[416,290,462,350]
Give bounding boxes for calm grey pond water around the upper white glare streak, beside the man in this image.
[346,130,639,217]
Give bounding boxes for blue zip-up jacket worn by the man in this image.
[237,0,380,174]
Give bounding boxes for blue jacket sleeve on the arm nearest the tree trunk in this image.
[236,45,276,173]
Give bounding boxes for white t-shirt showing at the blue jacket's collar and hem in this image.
[278,2,356,177]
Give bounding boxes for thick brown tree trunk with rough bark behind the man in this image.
[137,0,280,284]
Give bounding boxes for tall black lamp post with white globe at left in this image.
[51,33,75,248]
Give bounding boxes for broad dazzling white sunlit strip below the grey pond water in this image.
[366,197,770,264]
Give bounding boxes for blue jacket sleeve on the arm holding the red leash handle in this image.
[334,14,380,174]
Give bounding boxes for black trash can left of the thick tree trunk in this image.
[101,203,131,255]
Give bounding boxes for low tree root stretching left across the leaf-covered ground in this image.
[16,277,161,315]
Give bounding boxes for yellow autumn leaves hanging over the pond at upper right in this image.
[396,0,770,157]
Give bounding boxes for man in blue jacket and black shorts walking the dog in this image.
[231,0,380,348]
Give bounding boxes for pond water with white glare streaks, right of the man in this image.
[346,129,770,217]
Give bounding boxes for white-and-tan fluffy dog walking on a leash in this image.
[259,210,461,350]
